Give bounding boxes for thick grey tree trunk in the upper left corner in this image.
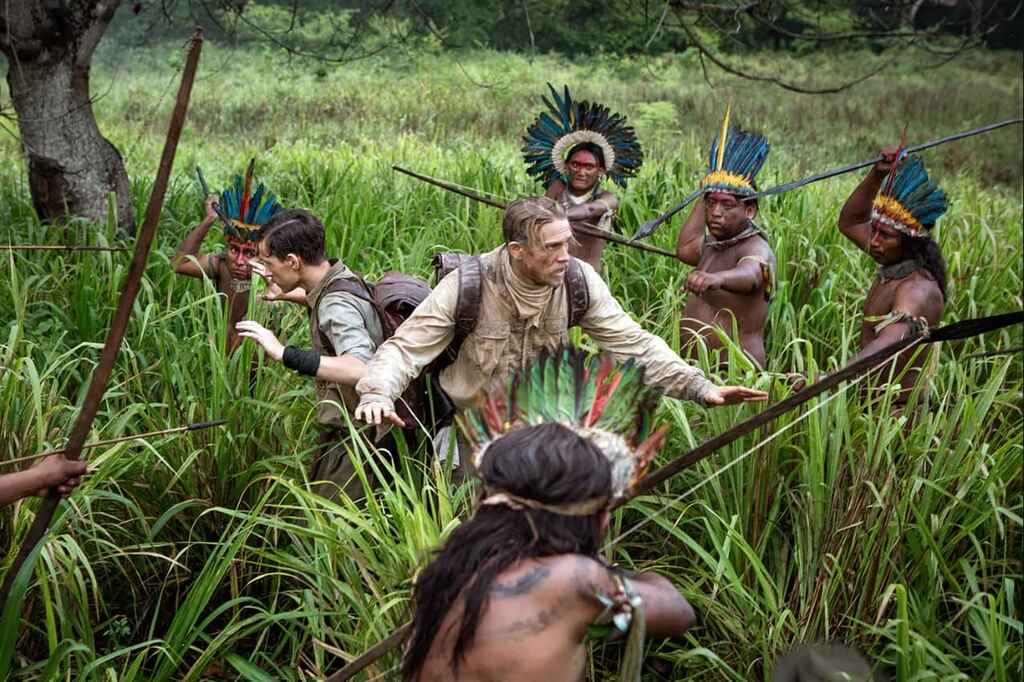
[0,0,134,232]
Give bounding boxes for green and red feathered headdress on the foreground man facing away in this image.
[457,346,667,515]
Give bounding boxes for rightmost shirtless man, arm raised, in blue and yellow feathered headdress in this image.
[839,146,948,403]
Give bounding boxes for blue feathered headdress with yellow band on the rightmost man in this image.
[871,152,949,238]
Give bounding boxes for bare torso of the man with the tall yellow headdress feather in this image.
[680,237,775,367]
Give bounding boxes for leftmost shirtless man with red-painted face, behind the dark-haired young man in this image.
[173,160,282,353]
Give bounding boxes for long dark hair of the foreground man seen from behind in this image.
[401,424,611,682]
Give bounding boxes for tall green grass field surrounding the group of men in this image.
[0,37,1024,682]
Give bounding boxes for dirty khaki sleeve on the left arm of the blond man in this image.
[355,270,459,407]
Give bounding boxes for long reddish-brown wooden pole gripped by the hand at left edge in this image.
[0,29,203,605]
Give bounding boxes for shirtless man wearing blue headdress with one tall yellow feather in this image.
[676,113,775,368]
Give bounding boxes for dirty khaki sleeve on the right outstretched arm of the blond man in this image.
[581,263,714,404]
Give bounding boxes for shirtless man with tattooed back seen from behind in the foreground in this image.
[402,349,695,682]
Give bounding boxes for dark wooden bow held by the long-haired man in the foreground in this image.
[326,310,1024,682]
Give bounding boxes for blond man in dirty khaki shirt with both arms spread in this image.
[355,197,768,426]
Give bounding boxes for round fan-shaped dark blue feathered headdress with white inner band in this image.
[522,83,643,187]
